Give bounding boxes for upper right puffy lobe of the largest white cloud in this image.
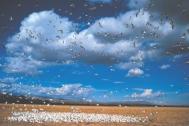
[88,9,172,39]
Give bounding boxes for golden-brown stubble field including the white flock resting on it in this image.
[0,104,189,126]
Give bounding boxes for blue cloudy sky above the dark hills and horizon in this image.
[0,0,189,105]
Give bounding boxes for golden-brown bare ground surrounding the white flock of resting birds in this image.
[0,104,189,126]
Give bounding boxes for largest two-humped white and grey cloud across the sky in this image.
[5,10,186,74]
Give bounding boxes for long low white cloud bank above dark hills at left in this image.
[0,82,94,99]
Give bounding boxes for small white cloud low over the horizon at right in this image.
[131,89,164,98]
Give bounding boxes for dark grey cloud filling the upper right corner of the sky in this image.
[128,0,189,55]
